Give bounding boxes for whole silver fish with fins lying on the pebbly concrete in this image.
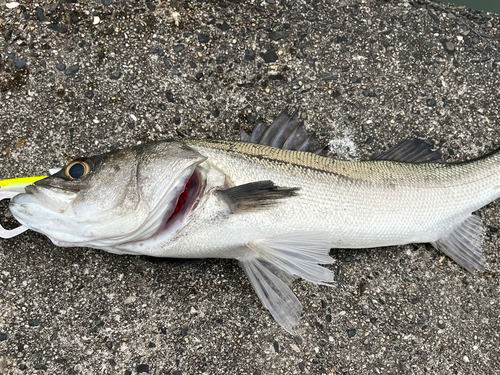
[9,108,500,334]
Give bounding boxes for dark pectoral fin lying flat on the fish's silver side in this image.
[219,181,300,213]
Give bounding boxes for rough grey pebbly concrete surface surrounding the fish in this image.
[0,0,500,375]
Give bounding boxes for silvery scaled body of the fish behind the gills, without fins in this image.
[132,142,500,258]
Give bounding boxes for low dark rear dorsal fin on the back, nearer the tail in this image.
[373,139,443,163]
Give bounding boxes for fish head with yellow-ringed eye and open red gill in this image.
[9,142,206,252]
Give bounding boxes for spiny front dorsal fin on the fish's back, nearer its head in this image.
[241,108,324,154]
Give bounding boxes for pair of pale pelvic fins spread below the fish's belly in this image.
[239,232,334,334]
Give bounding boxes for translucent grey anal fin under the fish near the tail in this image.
[432,215,486,273]
